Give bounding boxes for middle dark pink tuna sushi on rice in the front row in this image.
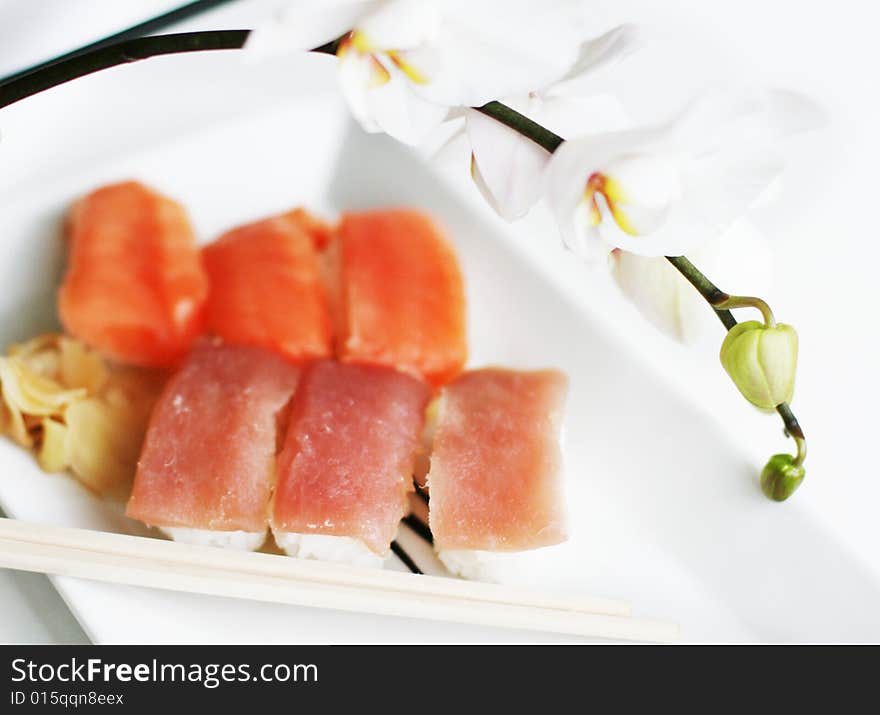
[271,360,430,565]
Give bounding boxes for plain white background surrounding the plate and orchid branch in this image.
[0,0,880,642]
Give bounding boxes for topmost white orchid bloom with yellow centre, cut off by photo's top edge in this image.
[248,0,600,144]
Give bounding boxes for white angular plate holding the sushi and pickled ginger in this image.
[0,53,880,643]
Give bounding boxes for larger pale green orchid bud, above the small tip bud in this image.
[721,320,798,410]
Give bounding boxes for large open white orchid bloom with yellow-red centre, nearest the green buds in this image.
[546,91,819,260]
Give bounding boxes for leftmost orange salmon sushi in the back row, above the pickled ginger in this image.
[58,181,208,366]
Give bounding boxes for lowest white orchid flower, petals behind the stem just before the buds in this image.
[609,219,772,343]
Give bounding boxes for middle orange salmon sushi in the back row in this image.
[202,210,333,361]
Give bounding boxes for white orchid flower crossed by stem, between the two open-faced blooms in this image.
[464,25,635,221]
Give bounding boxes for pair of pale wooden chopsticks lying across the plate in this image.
[0,519,678,642]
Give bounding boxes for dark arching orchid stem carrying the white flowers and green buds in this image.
[0,26,807,465]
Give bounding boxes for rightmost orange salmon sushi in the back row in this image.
[327,210,467,386]
